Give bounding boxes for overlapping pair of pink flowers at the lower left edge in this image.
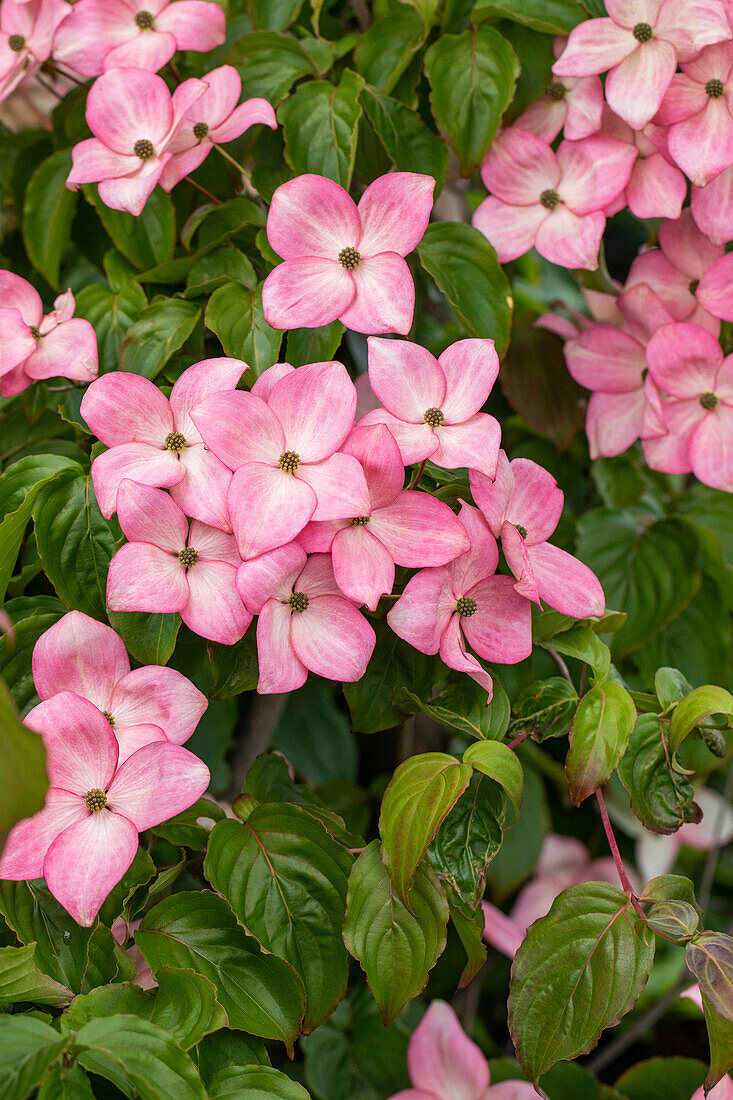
[0,612,209,926]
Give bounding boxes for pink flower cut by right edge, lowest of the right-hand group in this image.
[644,325,733,493]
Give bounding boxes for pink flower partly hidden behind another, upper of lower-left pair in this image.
[28,612,203,763]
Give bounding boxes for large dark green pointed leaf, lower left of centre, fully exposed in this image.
[204,804,353,1033]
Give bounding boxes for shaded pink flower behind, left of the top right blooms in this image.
[515,37,603,142]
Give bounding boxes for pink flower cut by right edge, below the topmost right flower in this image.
[656,42,733,187]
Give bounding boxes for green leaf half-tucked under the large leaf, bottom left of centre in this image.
[135,891,305,1049]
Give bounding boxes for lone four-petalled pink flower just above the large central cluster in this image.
[262,172,435,336]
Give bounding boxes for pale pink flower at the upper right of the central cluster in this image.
[360,337,501,477]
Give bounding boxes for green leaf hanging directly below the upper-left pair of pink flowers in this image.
[84,186,176,272]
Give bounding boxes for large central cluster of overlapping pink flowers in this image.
[81,337,604,697]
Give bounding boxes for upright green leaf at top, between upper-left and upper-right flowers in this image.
[425,24,519,176]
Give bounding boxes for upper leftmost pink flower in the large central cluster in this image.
[80,359,249,531]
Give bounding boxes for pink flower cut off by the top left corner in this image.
[0,0,72,101]
